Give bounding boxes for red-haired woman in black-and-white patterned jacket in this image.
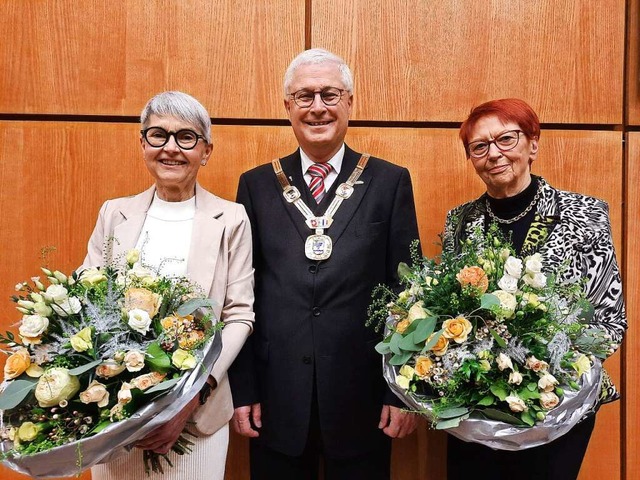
[444,98,627,480]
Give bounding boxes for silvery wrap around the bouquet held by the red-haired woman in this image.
[383,355,602,451]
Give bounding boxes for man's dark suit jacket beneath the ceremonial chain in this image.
[230,147,418,457]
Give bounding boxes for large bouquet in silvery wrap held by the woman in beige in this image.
[0,250,220,477]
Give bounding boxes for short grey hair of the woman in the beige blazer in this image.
[140,91,211,143]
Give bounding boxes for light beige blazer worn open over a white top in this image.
[82,184,254,435]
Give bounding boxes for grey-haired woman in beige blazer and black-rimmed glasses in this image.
[83,92,254,480]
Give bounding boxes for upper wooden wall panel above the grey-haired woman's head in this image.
[0,0,305,118]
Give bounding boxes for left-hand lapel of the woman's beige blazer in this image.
[108,186,156,261]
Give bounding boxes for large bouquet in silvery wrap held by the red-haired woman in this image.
[369,226,611,450]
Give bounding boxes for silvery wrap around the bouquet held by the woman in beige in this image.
[1,331,222,478]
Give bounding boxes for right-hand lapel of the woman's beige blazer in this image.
[187,184,224,294]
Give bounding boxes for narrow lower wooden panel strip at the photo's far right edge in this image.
[623,132,640,480]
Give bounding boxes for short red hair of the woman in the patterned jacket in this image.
[460,98,540,156]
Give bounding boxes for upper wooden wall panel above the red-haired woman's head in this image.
[311,0,625,124]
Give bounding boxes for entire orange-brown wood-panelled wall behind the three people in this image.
[0,0,640,480]
